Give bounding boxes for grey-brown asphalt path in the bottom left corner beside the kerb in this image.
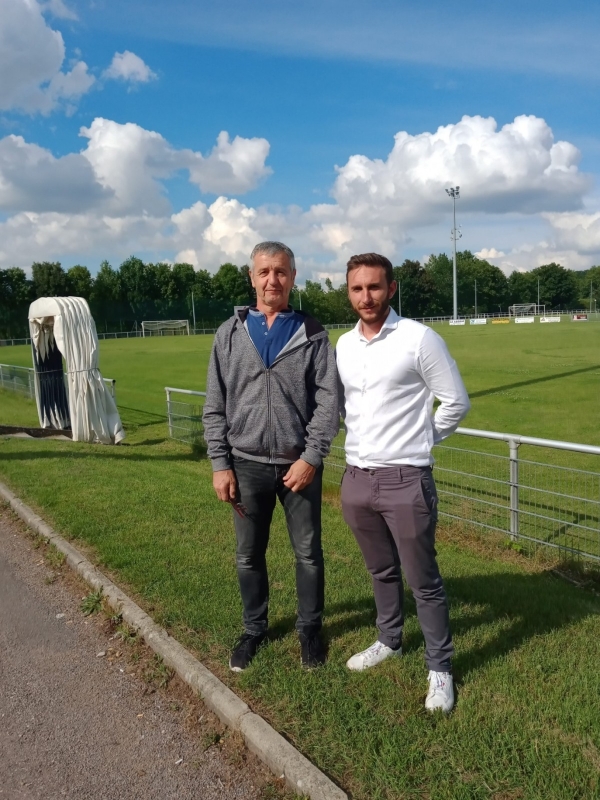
[0,506,273,800]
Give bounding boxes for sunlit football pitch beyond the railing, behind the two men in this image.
[0,320,600,445]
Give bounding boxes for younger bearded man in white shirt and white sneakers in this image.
[336,253,470,712]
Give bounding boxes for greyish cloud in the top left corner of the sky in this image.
[0,0,95,114]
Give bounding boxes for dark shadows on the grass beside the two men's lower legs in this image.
[270,572,600,677]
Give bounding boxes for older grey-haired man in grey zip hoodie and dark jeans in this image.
[203,242,339,672]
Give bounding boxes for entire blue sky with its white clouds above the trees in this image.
[0,0,600,279]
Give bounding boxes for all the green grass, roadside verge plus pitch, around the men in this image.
[0,322,600,800]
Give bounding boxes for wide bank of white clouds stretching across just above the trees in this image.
[0,111,600,276]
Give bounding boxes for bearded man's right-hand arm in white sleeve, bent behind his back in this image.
[417,329,471,444]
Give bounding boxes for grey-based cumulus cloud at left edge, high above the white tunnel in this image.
[0,117,270,222]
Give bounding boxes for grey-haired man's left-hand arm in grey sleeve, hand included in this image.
[202,337,237,502]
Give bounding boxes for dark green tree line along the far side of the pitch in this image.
[0,250,600,338]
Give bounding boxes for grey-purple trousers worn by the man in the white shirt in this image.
[342,466,454,672]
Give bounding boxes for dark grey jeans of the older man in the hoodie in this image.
[233,456,325,634]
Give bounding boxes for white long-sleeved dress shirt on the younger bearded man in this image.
[336,308,471,468]
